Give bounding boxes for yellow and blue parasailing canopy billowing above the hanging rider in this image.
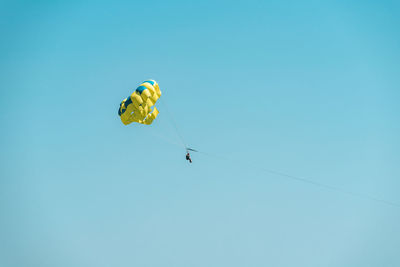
[118,80,161,125]
